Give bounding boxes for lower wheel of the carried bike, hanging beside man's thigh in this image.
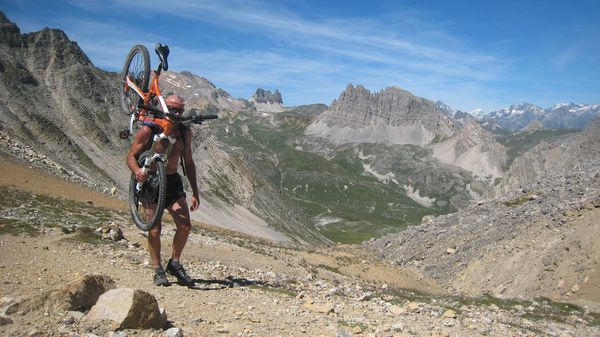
[129,152,167,231]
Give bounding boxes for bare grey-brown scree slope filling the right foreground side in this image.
[366,117,600,310]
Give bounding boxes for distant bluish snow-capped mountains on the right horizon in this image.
[472,103,600,131]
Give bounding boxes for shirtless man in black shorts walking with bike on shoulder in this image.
[127,95,200,286]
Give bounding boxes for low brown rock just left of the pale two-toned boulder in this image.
[6,275,116,315]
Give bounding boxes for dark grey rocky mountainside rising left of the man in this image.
[0,13,128,186]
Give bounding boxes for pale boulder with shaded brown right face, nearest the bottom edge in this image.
[86,288,163,329]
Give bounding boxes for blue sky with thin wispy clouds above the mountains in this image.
[0,0,600,111]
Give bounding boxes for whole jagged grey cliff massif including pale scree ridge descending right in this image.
[305,85,506,180]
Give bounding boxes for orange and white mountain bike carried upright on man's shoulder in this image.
[119,43,218,231]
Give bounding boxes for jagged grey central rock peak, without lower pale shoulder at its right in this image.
[306,84,456,145]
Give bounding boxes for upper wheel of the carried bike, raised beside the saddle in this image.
[120,45,150,115]
